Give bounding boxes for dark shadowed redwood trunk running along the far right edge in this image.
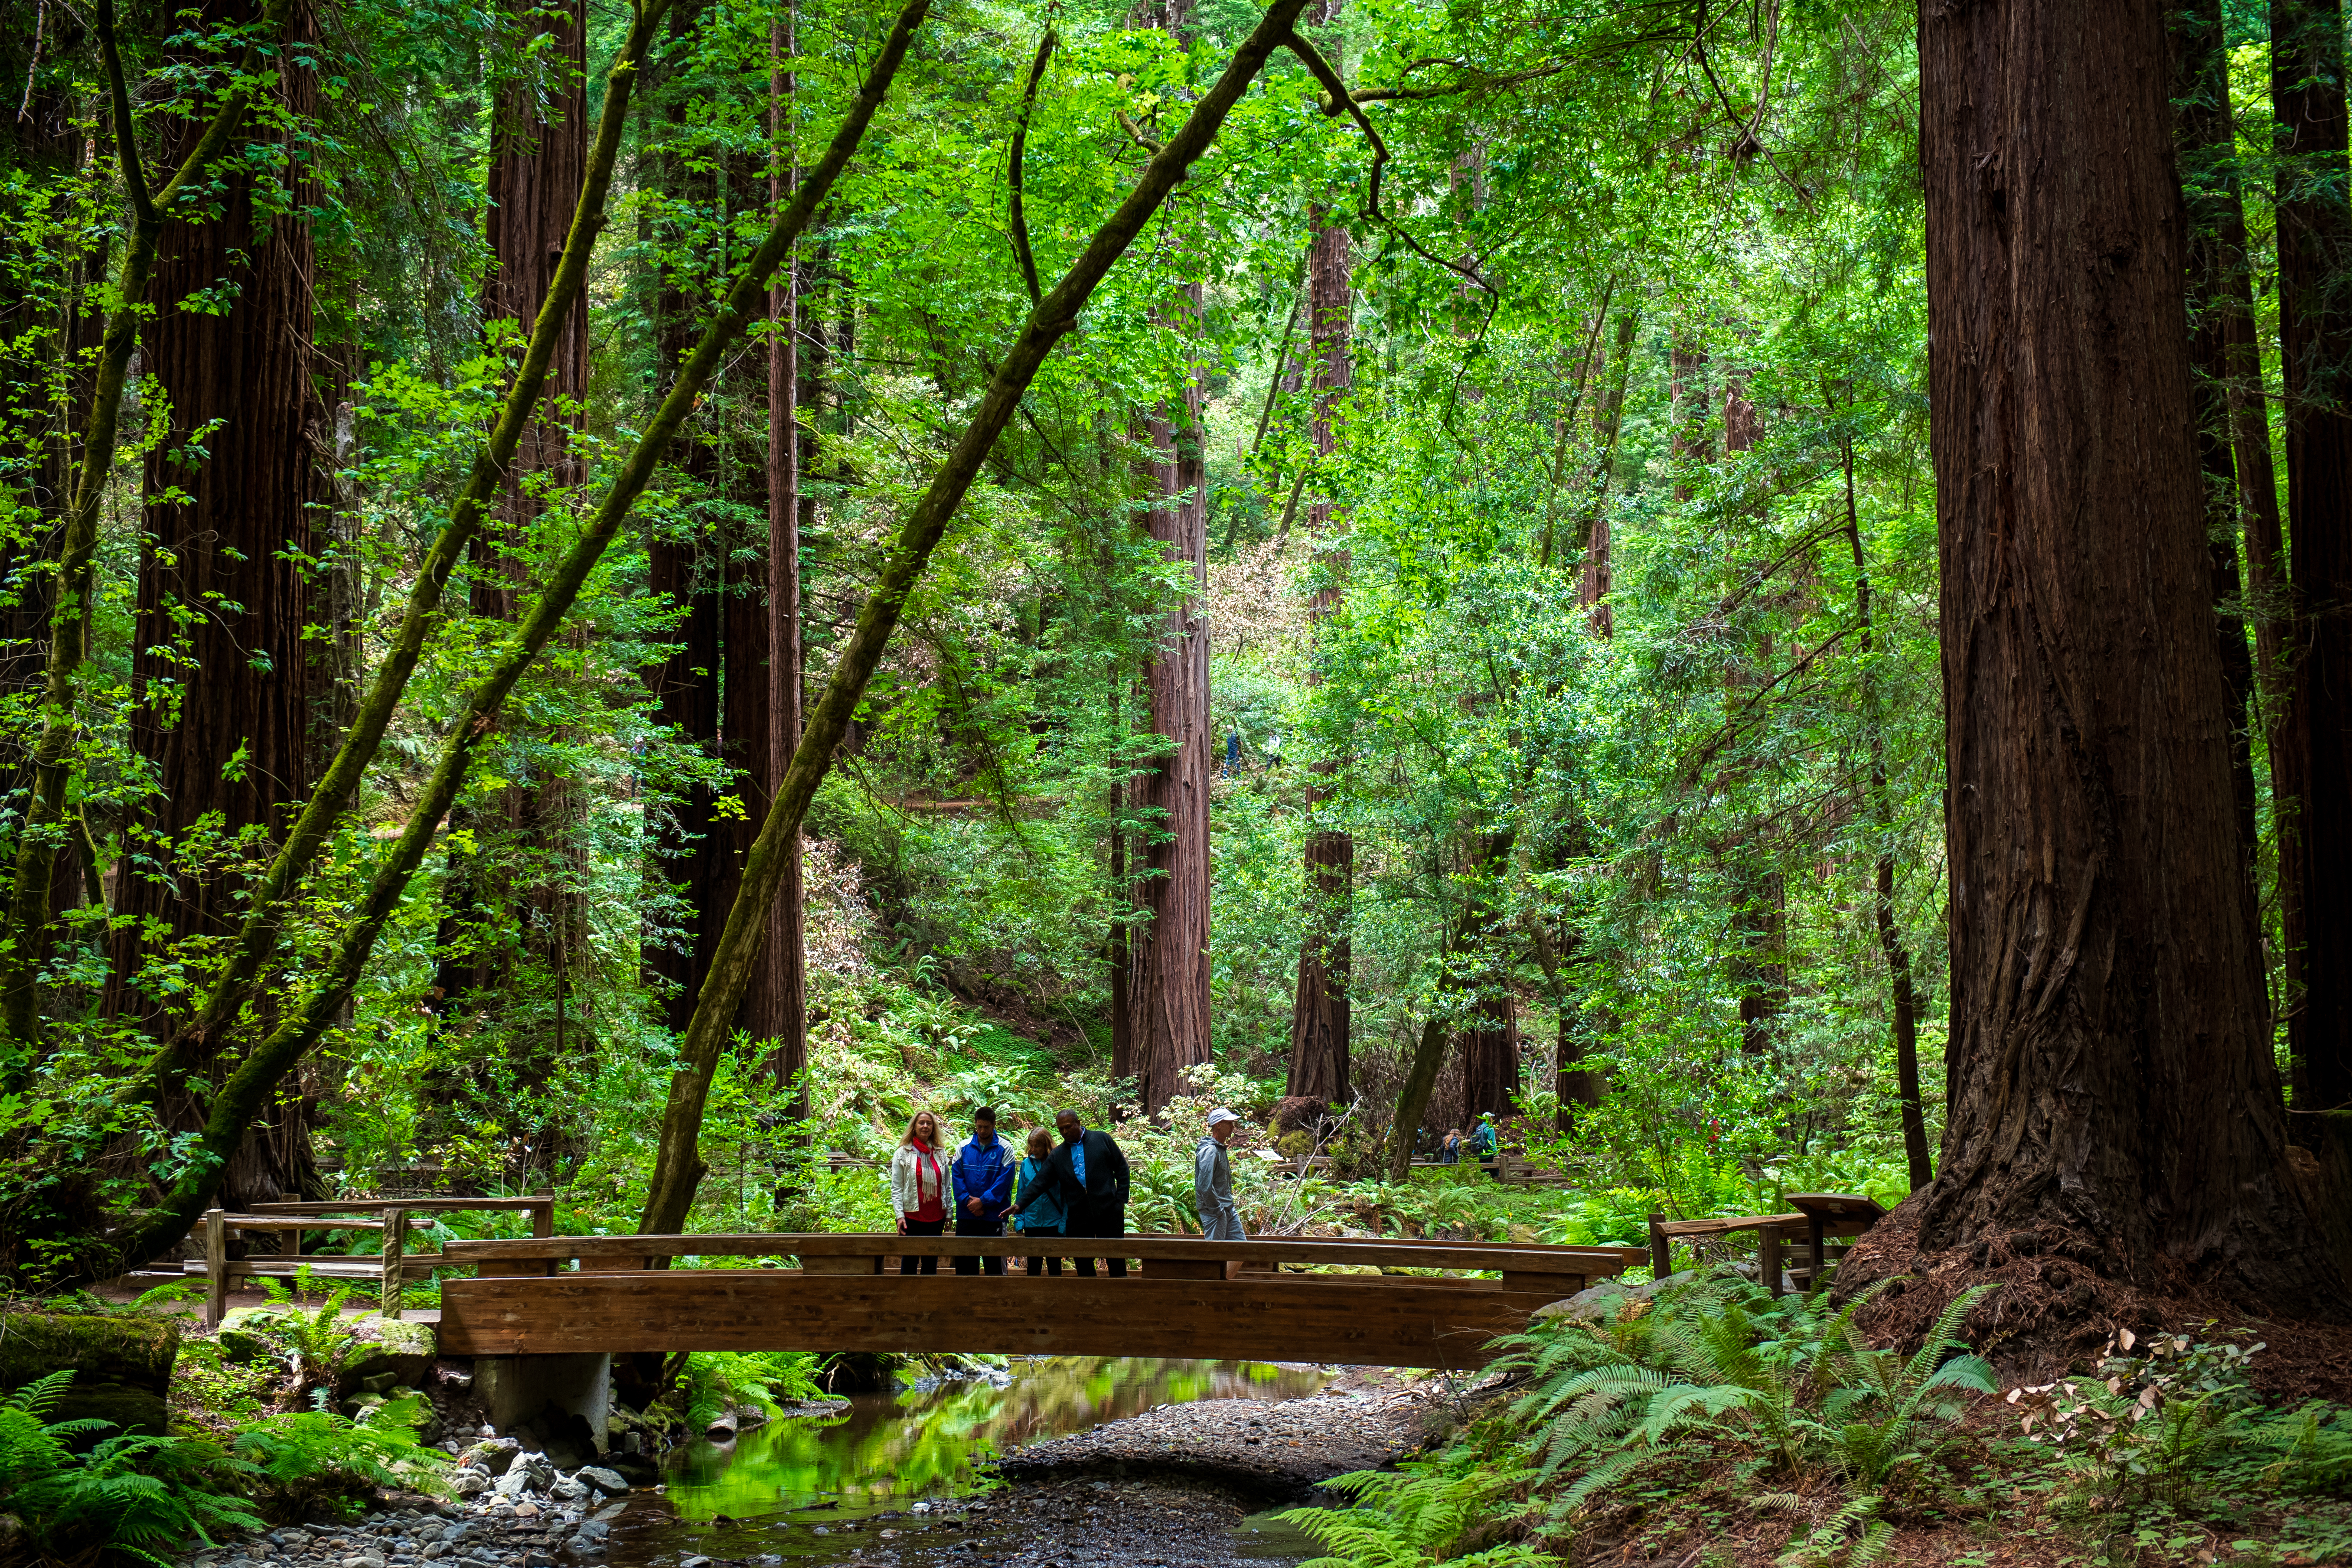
[2270,0,2352,1152]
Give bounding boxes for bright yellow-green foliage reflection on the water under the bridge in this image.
[663,1356,1324,1521]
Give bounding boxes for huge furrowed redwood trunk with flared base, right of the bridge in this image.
[1839,0,2345,1347]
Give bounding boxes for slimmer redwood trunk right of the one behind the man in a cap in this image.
[1286,208,1355,1105]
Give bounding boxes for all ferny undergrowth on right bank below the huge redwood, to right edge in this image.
[1284,1274,2352,1568]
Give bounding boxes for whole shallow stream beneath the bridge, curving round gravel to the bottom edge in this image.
[609,1356,1329,1568]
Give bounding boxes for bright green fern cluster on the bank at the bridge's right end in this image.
[1284,1281,1992,1568]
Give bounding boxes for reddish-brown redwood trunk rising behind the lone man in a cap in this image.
[1127,284,1211,1112]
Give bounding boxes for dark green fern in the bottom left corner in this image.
[0,1368,261,1568]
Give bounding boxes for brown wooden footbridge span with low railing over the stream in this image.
[440,1234,1644,1368]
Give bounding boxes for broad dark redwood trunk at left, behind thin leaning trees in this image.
[106,0,332,1206]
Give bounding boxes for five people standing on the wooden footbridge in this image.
[889,1105,1244,1279]
